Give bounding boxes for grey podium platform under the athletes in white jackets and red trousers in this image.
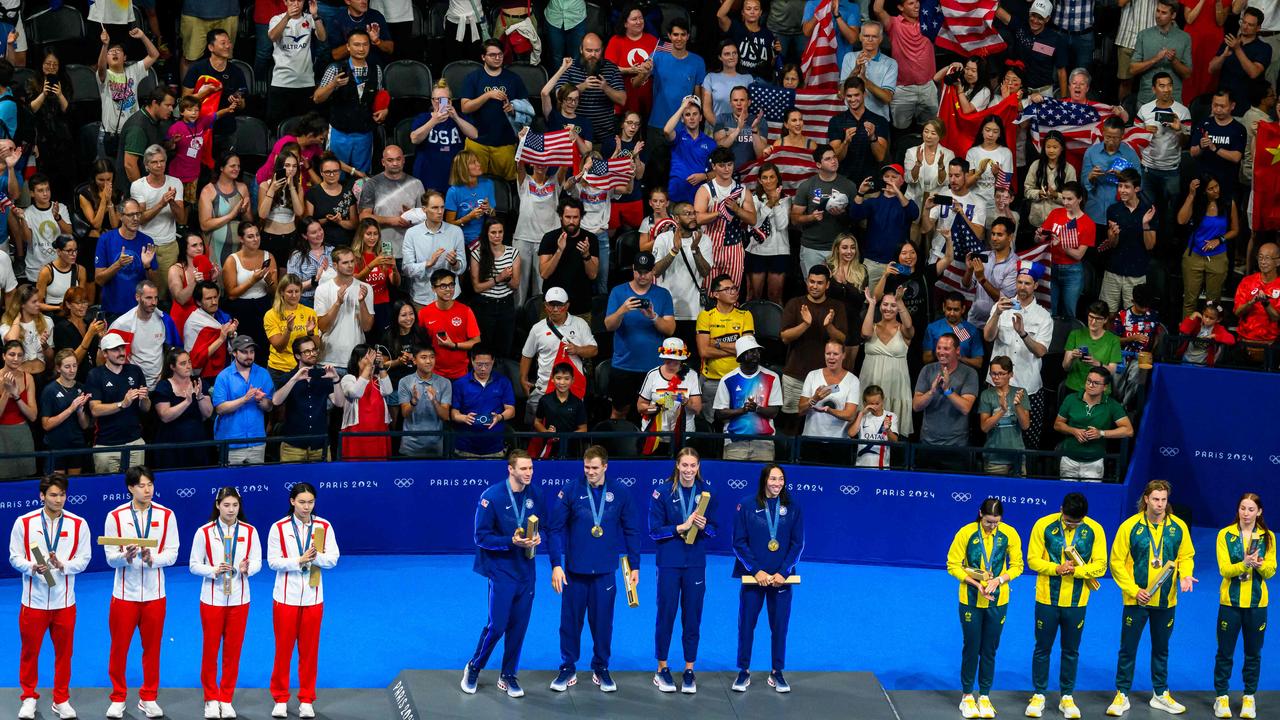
[0,688,396,720]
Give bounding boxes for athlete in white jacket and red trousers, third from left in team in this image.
[189,487,262,719]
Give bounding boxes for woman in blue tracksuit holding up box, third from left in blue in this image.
[649,447,717,693]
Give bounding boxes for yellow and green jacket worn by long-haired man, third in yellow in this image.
[1111,512,1196,607]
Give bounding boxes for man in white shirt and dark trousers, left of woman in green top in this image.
[982,261,1053,450]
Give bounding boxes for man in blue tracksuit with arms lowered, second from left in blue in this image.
[547,445,640,693]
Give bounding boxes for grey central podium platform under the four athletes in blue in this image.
[390,670,906,720]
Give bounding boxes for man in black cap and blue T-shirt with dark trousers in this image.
[604,252,676,419]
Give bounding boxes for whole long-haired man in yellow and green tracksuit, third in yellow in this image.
[1107,480,1197,716]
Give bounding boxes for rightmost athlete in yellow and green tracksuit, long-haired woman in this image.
[1213,492,1276,717]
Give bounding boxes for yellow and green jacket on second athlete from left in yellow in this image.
[1027,512,1107,607]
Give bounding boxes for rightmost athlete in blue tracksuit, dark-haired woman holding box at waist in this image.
[733,464,804,693]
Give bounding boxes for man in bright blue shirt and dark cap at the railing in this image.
[214,334,275,465]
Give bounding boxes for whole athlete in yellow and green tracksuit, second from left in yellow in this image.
[1025,492,1107,717]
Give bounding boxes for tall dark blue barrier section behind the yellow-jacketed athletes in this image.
[1126,365,1280,528]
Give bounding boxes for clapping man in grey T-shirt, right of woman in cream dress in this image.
[911,333,978,470]
